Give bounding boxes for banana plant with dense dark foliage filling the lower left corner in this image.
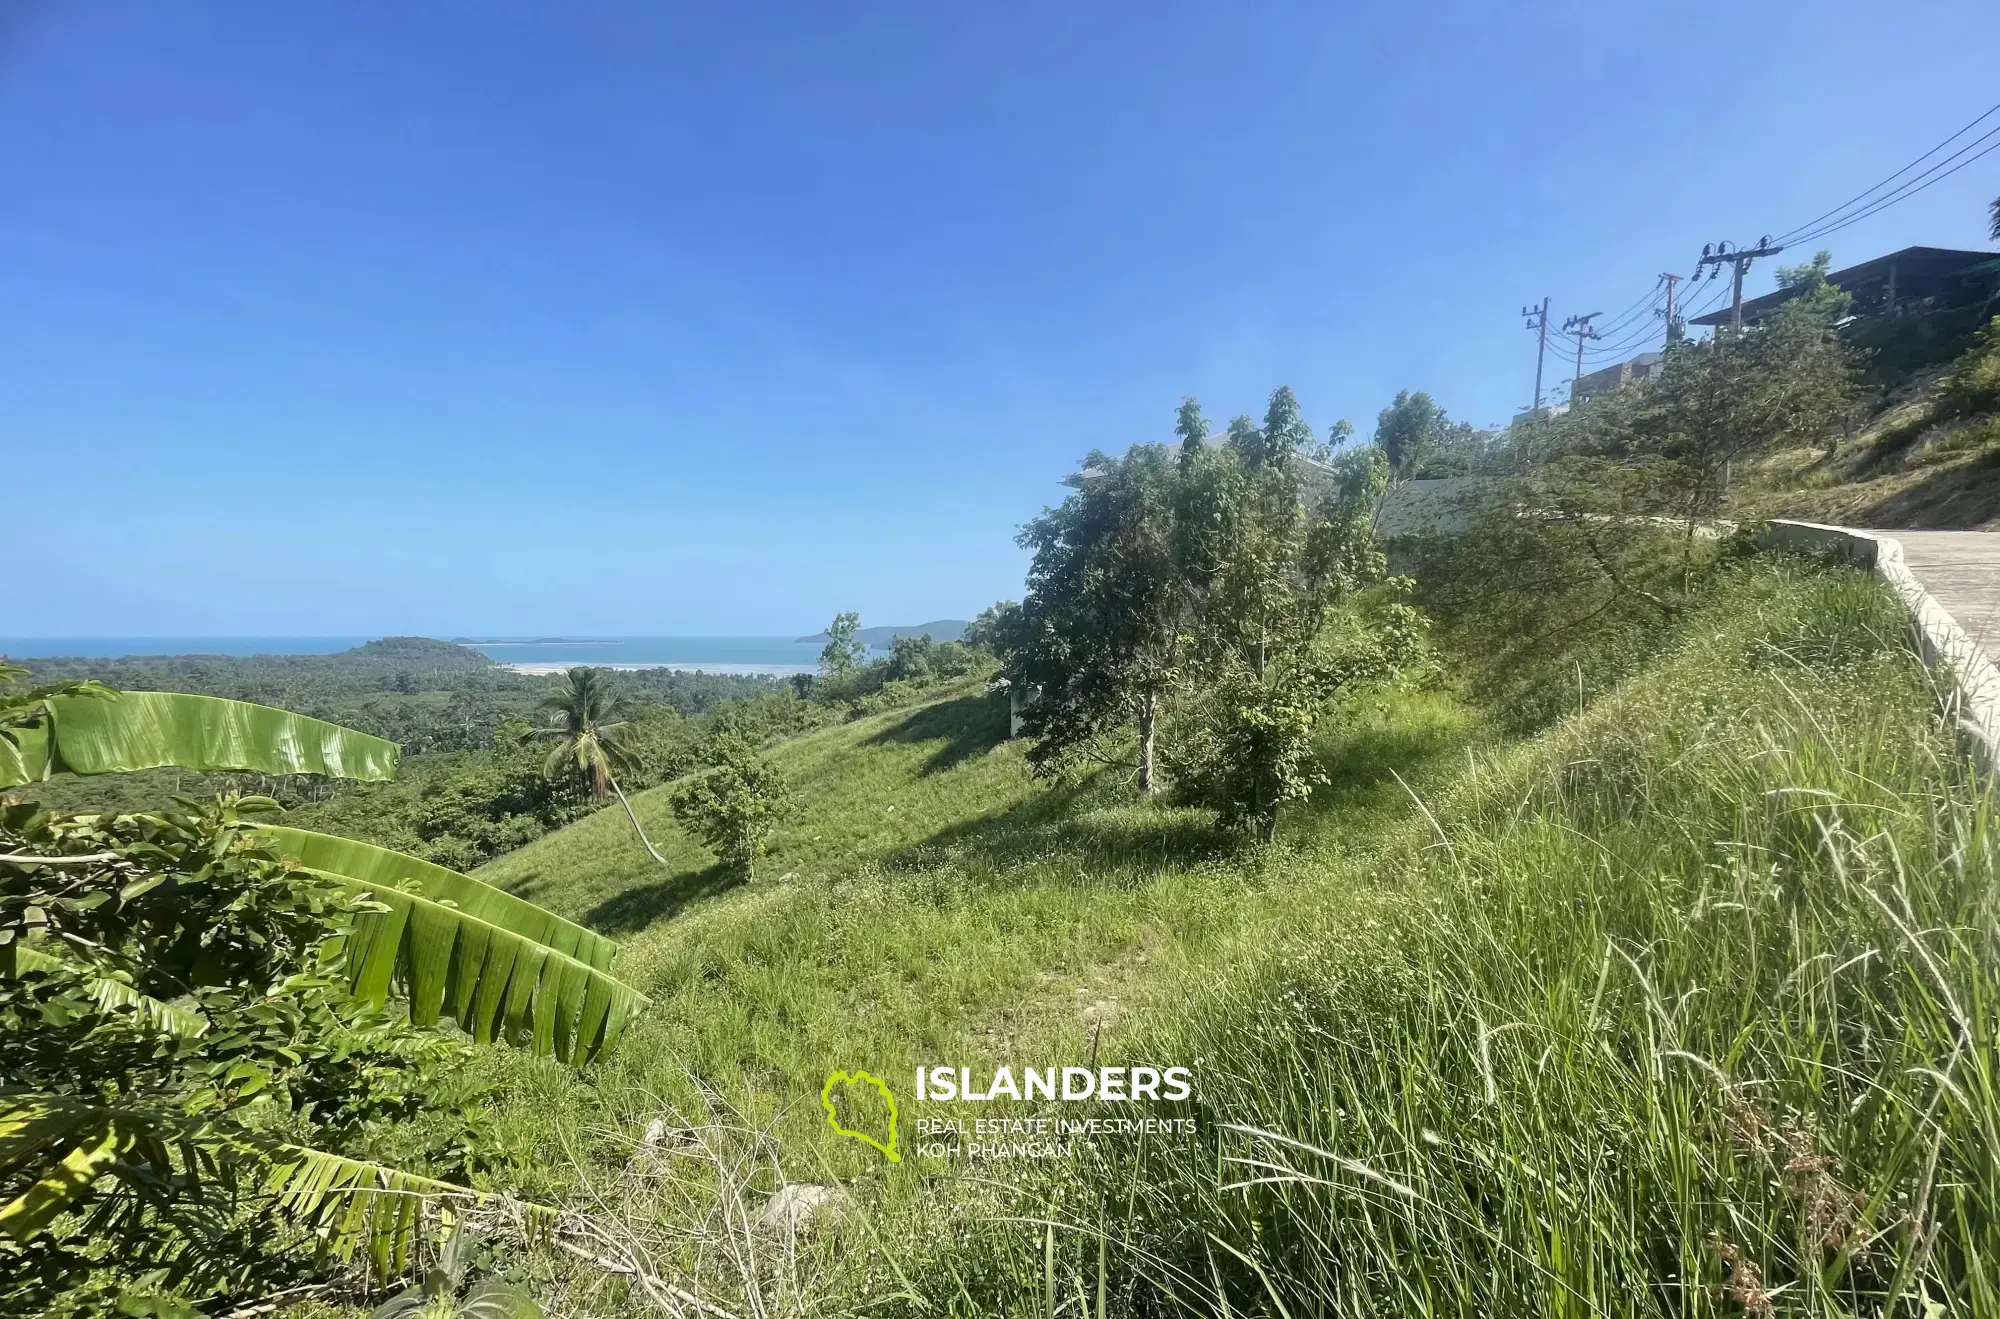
[0,669,644,1313]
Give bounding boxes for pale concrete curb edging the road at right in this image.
[1756,520,2000,791]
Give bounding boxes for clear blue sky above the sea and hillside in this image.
[0,0,2000,636]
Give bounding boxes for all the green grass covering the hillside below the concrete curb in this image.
[464,562,2000,1315]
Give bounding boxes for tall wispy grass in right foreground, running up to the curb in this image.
[928,564,2000,1319]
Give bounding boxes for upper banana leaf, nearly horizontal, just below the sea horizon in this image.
[0,691,402,787]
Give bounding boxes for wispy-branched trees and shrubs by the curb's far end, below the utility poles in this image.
[1418,275,1856,725]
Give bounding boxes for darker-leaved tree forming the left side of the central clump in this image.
[1006,439,1198,795]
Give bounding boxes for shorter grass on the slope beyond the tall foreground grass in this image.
[460,685,1480,1255]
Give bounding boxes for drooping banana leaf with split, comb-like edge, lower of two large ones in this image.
[328,875,648,1065]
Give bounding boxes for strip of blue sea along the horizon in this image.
[0,636,888,677]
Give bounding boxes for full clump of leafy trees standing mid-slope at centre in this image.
[1006,388,1414,837]
